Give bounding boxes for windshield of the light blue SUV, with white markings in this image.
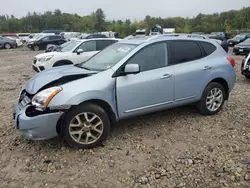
[78,43,136,71]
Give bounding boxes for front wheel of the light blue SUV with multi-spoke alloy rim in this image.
[61,103,110,149]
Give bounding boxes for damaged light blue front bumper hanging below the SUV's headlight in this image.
[13,104,64,140]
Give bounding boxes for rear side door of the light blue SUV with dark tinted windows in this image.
[171,40,216,105]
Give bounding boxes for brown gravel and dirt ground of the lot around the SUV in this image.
[0,49,250,188]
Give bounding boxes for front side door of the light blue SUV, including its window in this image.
[116,42,174,118]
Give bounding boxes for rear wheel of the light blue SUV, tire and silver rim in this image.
[197,82,226,116]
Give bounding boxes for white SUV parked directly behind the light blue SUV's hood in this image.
[32,38,121,72]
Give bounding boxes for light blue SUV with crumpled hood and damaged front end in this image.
[14,35,236,148]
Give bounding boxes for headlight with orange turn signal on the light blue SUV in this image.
[32,87,62,109]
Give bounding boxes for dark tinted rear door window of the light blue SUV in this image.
[171,40,202,64]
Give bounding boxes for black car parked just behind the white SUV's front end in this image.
[28,35,68,51]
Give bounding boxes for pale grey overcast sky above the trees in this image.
[0,0,250,20]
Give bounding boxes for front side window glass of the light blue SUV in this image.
[127,42,168,72]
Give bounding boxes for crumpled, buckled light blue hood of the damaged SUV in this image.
[23,65,97,95]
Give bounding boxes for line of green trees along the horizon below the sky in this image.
[0,6,250,37]
